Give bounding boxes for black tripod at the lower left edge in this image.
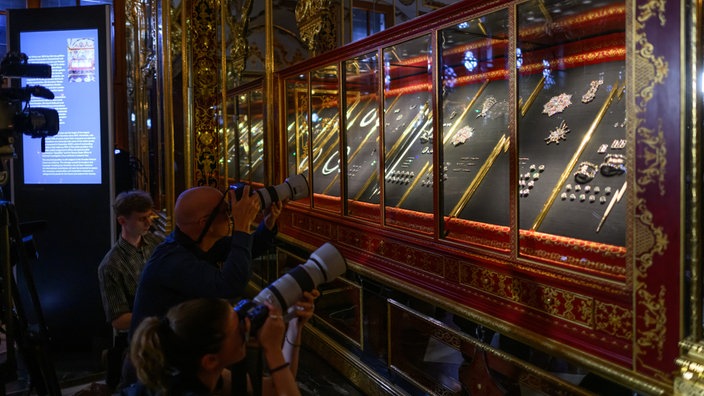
[0,200,61,396]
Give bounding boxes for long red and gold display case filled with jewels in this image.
[278,0,684,393]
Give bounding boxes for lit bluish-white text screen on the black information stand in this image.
[20,29,102,184]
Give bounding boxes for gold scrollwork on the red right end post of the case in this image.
[630,0,672,372]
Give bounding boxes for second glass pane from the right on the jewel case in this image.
[438,10,511,244]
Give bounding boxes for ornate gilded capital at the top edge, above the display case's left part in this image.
[296,0,337,56]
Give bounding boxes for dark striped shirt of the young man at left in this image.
[98,233,162,323]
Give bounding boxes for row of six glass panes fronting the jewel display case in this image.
[285,0,630,270]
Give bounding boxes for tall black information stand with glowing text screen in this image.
[7,5,116,353]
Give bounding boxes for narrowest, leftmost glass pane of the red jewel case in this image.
[285,74,309,207]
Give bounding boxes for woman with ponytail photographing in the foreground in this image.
[123,290,319,396]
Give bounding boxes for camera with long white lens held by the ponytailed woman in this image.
[235,242,347,336]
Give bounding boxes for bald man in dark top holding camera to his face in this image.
[130,186,283,335]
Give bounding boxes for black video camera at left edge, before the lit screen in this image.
[0,52,59,164]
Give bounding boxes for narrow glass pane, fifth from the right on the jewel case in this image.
[310,66,342,212]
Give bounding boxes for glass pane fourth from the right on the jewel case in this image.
[344,53,381,220]
